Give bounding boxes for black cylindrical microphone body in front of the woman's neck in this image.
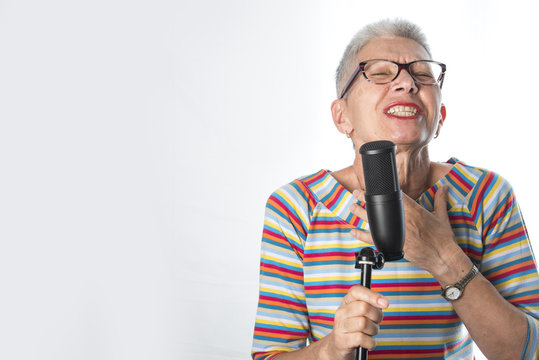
[359,141,404,261]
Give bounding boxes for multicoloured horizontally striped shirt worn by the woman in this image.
[252,159,539,360]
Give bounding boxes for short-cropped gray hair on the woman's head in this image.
[335,19,432,96]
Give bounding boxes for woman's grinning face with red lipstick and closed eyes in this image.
[332,37,445,149]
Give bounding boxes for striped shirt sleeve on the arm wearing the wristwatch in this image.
[479,173,539,360]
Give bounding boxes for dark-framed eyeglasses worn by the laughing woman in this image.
[339,59,446,99]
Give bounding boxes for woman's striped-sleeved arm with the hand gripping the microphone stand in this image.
[252,187,389,360]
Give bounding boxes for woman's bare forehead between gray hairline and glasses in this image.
[358,37,430,63]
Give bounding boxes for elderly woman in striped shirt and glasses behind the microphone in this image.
[252,20,539,360]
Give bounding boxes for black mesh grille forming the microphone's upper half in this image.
[359,141,400,195]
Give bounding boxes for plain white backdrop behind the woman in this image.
[0,0,539,360]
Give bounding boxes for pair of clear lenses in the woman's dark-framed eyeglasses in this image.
[364,60,442,84]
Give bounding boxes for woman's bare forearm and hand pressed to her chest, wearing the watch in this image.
[353,184,537,359]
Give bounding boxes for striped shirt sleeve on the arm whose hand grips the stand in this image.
[251,185,310,360]
